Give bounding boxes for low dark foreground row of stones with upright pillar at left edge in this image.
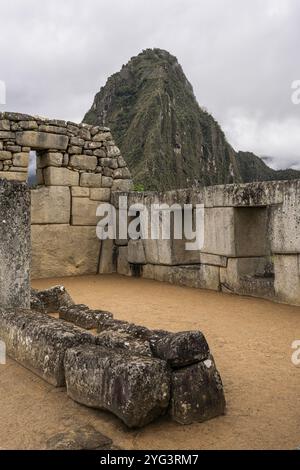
[0,180,225,428]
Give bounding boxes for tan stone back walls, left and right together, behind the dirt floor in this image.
[0,113,300,305]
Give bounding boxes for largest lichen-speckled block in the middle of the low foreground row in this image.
[65,346,170,428]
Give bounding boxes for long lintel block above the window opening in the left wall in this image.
[16,131,69,150]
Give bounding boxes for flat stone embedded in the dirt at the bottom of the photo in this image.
[46,425,113,450]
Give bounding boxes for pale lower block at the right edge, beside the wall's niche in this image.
[273,254,300,305]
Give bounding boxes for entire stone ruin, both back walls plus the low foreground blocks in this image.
[0,113,300,427]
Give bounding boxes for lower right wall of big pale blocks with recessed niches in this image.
[112,181,300,305]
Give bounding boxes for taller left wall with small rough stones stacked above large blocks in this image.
[0,113,131,278]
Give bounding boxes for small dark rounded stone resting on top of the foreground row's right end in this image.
[152,331,209,368]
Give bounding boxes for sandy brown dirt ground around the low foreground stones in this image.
[0,275,300,450]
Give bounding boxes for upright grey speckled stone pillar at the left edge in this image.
[0,179,31,308]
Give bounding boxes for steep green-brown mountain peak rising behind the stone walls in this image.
[84,49,298,190]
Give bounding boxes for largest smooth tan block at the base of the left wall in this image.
[31,225,100,279]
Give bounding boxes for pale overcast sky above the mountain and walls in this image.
[0,0,300,169]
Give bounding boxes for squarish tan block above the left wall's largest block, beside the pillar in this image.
[31,186,71,224]
